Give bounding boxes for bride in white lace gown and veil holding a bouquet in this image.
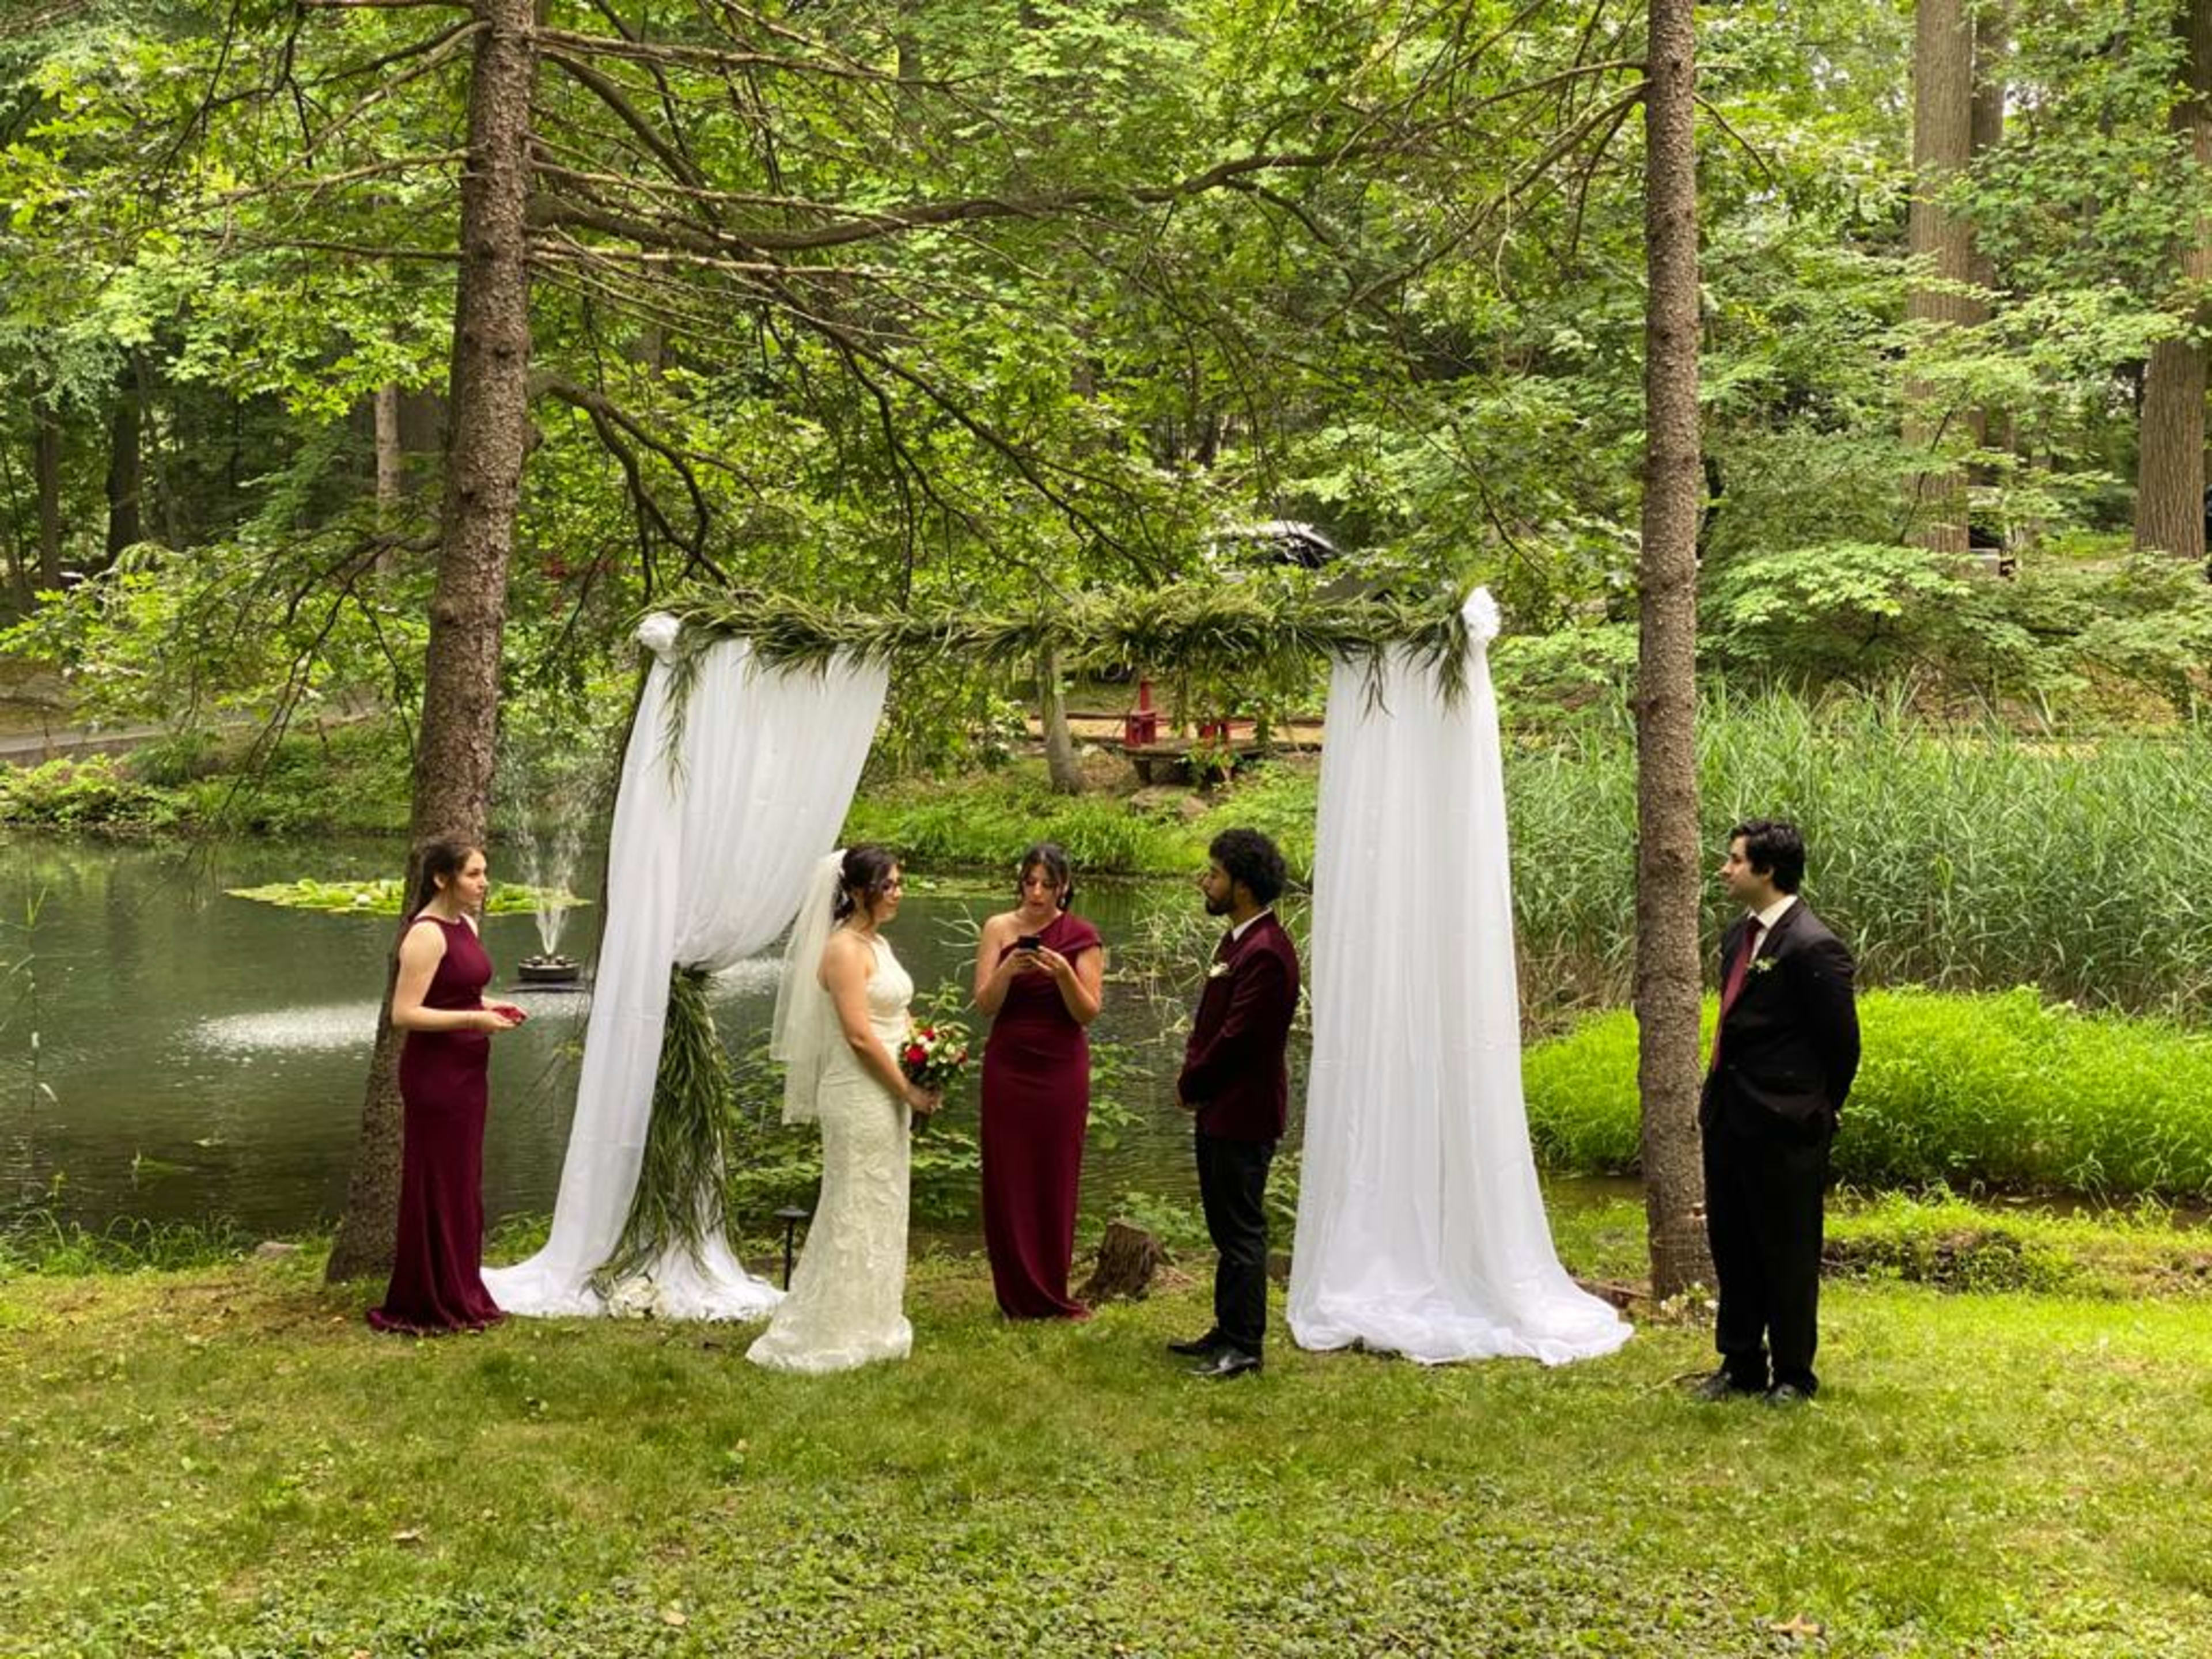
[745,847,938,1372]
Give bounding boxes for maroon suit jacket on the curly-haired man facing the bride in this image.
[1175,911,1298,1141]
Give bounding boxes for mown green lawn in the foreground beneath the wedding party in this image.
[0,1203,2212,1657]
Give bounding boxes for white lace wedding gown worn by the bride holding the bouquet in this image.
[745,938,914,1372]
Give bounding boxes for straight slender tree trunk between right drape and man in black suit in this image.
[1635,0,1712,1298]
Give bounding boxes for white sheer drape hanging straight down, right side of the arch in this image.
[1290,590,1628,1365]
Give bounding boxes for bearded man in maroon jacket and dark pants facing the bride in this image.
[1168,830,1298,1380]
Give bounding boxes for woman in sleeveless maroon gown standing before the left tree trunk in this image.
[369,840,522,1334]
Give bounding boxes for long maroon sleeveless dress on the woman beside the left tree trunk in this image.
[369,916,505,1334]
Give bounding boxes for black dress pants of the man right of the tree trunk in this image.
[1703,1113,1834,1393]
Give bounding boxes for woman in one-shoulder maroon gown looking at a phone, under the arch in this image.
[975,840,1106,1319]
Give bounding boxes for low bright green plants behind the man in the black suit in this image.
[1522,988,2212,1199]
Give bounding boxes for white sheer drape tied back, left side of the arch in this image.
[484,617,885,1319]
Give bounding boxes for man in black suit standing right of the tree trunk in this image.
[1696,819,1858,1404]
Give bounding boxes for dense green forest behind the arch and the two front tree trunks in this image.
[0,0,2212,767]
